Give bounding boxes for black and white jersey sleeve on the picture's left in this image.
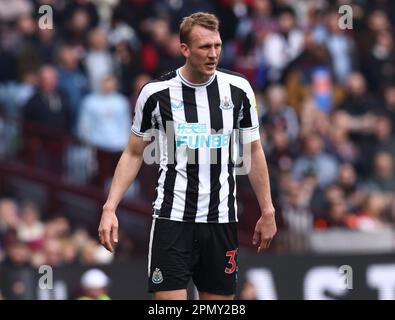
[132,86,156,137]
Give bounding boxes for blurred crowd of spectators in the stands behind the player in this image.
[0,0,395,266]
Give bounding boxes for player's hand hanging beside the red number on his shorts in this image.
[252,209,277,253]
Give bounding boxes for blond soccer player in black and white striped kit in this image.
[99,12,276,299]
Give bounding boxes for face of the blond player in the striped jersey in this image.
[181,26,222,81]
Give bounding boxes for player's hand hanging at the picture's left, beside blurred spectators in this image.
[99,210,118,252]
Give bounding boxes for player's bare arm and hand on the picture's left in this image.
[99,133,149,252]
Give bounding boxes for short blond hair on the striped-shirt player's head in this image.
[180,12,219,44]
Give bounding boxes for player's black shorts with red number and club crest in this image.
[148,218,238,295]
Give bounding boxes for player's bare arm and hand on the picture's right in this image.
[248,140,277,253]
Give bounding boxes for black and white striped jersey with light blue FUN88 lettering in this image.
[132,69,259,223]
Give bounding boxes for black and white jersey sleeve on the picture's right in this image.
[239,81,260,144]
